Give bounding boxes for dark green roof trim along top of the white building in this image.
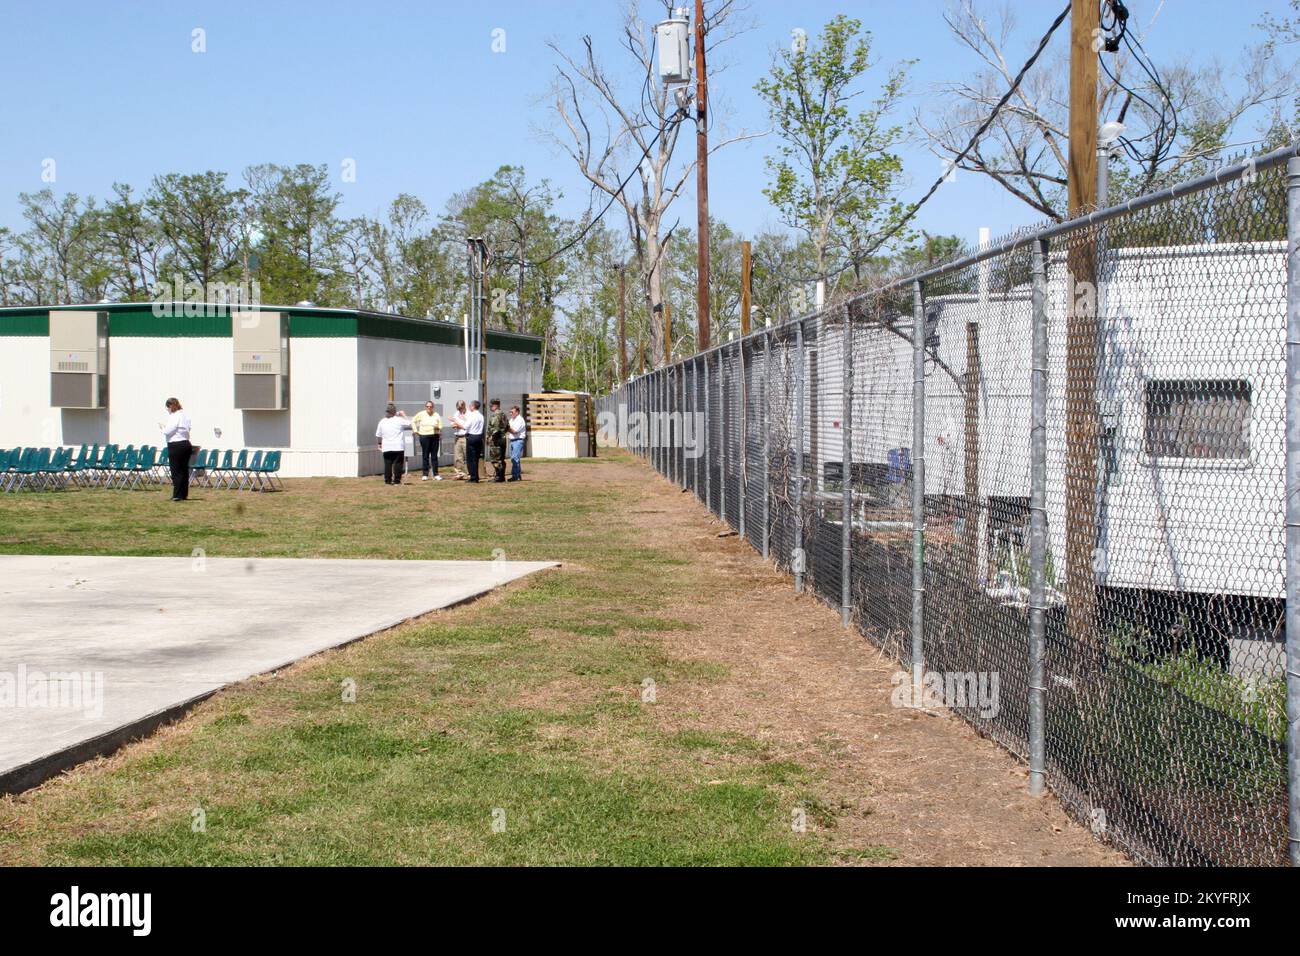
[0,302,542,355]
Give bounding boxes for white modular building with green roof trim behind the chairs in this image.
[0,302,542,477]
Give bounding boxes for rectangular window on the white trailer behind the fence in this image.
[1145,378,1251,459]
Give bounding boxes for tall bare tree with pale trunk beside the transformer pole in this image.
[547,0,755,356]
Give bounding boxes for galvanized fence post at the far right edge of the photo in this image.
[1286,156,1300,866]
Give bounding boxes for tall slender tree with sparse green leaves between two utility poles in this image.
[754,14,907,295]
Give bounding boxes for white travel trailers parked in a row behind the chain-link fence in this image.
[805,242,1286,616]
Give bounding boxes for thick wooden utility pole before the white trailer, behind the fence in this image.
[1065,0,1100,646]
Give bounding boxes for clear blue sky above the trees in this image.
[0,0,1287,247]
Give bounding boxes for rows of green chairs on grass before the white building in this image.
[0,445,283,492]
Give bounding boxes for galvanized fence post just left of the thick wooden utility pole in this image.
[1030,239,1048,795]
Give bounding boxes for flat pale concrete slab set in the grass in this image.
[0,555,556,792]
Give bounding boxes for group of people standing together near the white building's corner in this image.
[374,398,528,485]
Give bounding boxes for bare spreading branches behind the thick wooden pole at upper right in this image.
[917,0,1295,220]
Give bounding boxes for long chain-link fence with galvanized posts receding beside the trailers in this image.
[598,148,1300,865]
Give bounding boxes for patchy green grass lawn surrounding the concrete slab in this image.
[0,455,863,865]
